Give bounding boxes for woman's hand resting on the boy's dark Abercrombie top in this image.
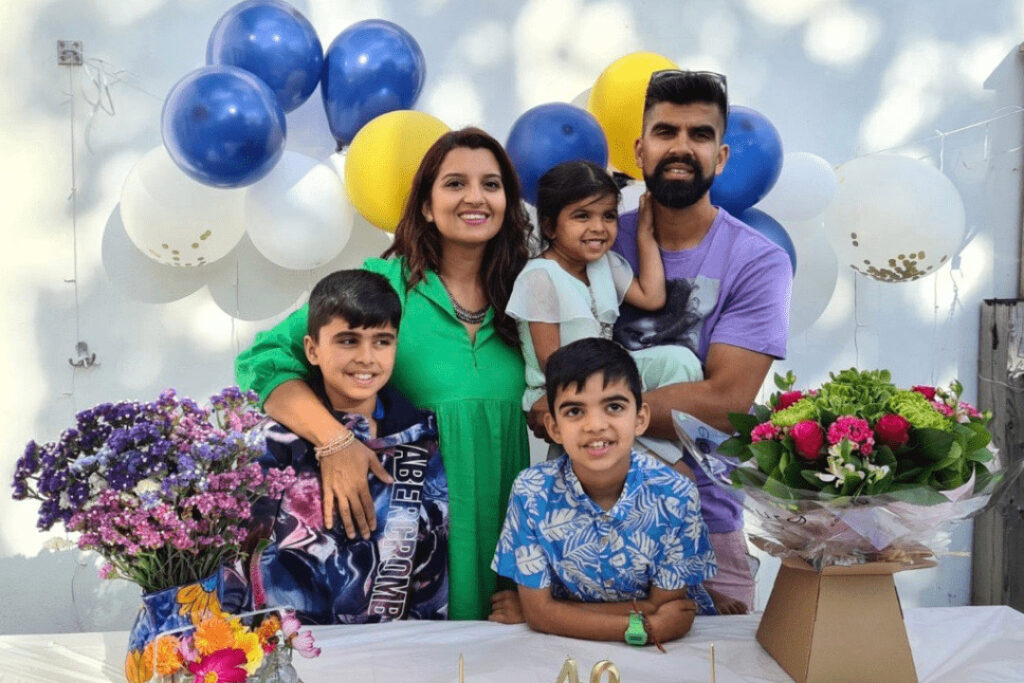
[321,439,392,539]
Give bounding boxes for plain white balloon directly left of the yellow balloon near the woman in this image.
[245,150,354,270]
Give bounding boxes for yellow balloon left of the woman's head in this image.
[345,110,449,232]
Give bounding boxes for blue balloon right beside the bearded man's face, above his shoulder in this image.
[711,106,782,216]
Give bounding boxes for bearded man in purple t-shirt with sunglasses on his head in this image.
[612,71,793,611]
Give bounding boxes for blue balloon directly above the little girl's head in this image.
[505,102,608,204]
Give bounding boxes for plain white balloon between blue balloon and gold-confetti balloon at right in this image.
[757,152,839,223]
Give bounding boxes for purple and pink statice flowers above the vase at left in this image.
[13,387,294,592]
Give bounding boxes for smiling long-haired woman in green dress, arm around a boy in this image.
[236,128,529,620]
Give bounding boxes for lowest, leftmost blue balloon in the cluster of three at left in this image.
[161,66,286,187]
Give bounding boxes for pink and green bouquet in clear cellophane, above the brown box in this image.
[697,369,1020,569]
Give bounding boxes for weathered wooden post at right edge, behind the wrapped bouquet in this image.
[971,299,1024,610]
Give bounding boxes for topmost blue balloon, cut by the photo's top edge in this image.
[206,0,324,113]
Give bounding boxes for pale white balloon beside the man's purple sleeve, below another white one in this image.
[785,216,839,335]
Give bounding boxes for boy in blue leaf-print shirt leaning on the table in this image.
[490,339,717,644]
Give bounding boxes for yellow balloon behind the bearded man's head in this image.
[587,52,679,179]
